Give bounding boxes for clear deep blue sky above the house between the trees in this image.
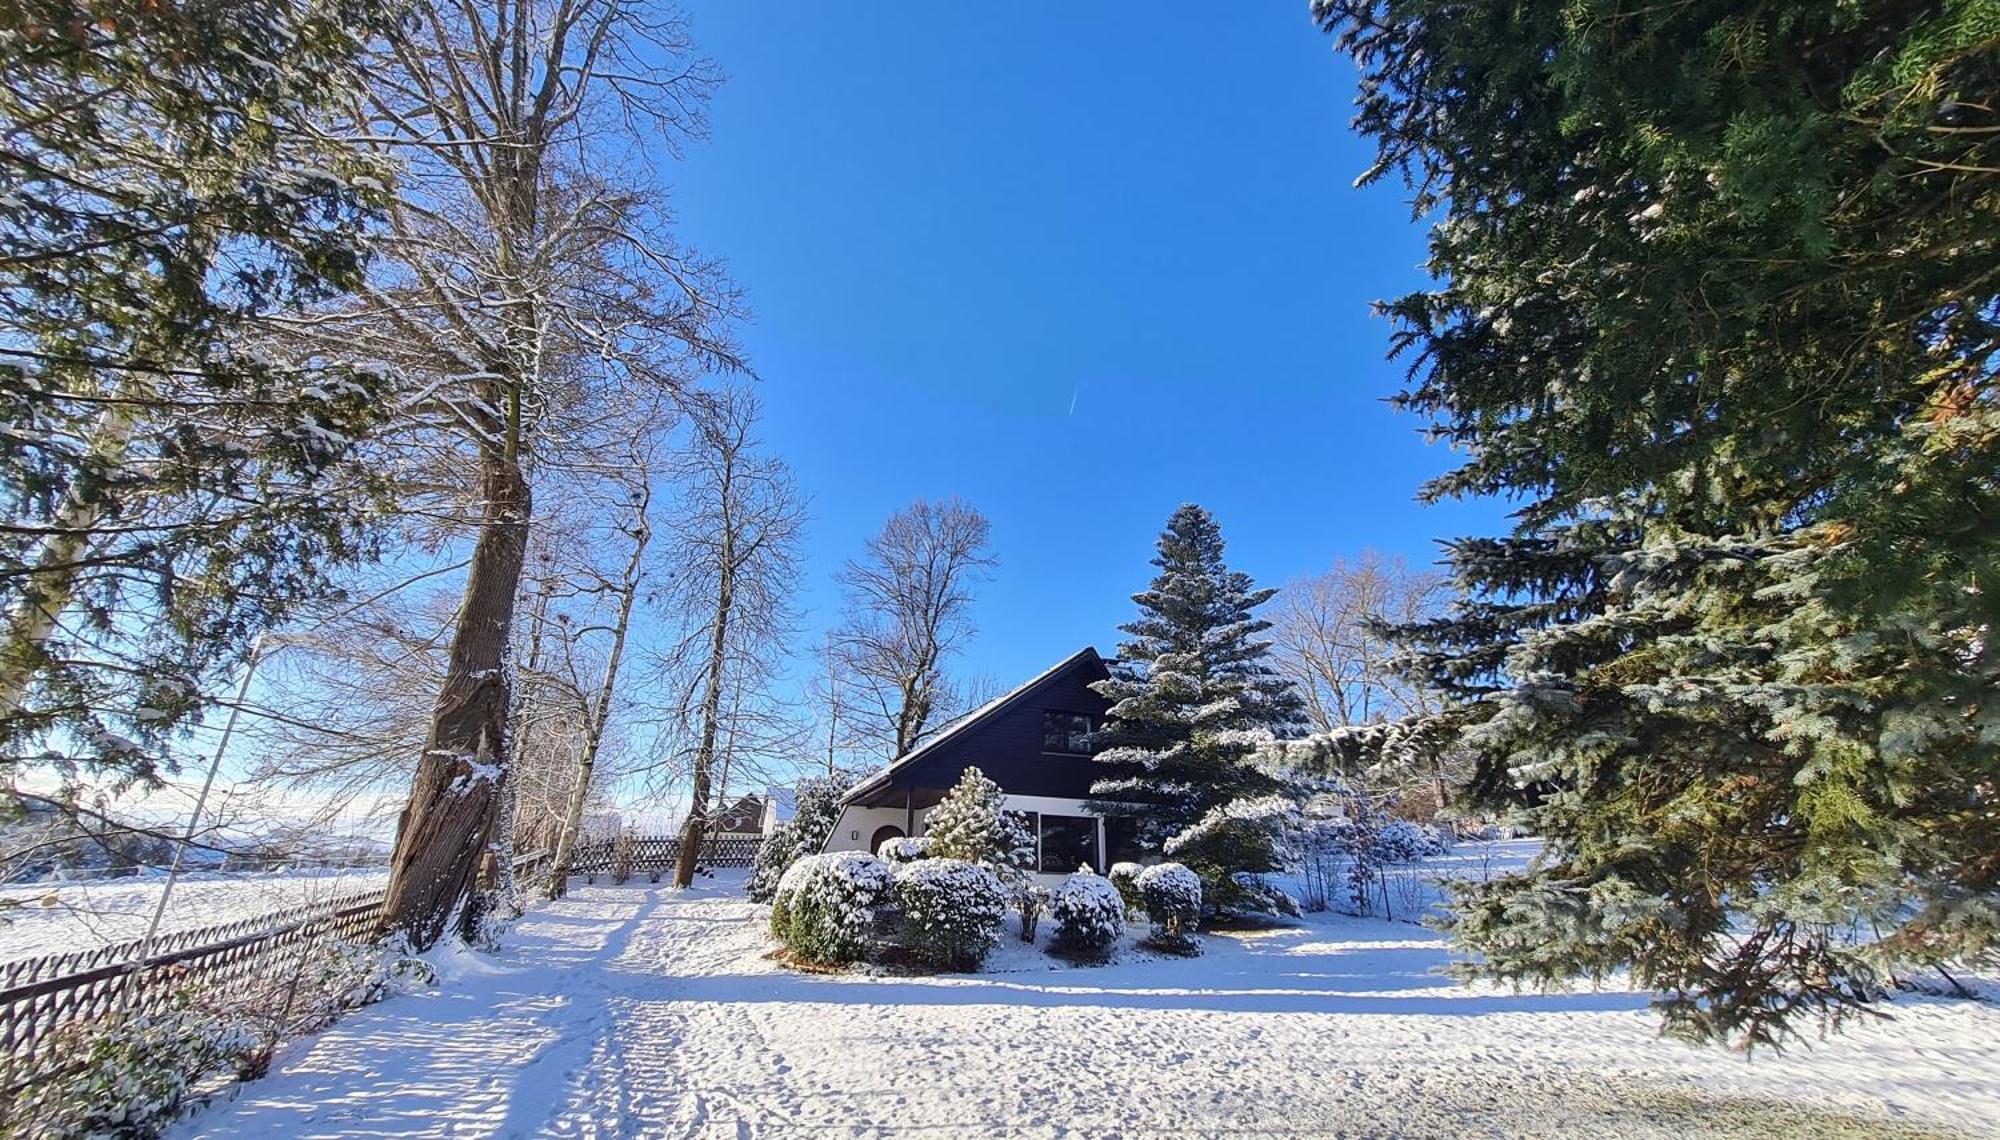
[668,0,1498,684]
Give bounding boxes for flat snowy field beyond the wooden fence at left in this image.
[0,870,388,962]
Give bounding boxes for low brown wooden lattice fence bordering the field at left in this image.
[0,852,550,1134]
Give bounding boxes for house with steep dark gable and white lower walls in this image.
[826,646,1138,876]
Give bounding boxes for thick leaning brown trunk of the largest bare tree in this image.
[382,446,530,950]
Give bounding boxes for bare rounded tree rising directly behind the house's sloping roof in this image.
[836,496,996,760]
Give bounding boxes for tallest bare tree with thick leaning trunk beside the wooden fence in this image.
[280,0,736,946]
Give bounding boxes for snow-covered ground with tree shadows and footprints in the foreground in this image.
[180,886,2000,1140]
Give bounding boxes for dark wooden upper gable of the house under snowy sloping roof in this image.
[848,648,1110,808]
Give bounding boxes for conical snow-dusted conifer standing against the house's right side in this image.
[1090,504,1302,888]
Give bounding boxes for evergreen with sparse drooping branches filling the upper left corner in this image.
[0,0,394,782]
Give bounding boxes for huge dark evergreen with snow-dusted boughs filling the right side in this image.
[1316,0,2000,1046]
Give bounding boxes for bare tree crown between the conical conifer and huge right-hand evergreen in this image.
[1270,550,1446,732]
